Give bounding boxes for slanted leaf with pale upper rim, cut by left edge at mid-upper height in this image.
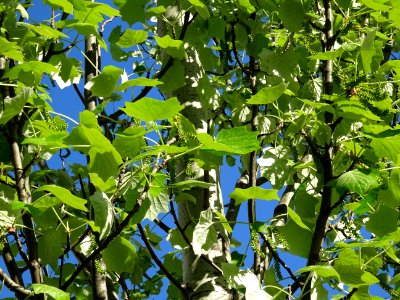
[0,87,33,125]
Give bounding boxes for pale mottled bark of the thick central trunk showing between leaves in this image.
[158,1,234,299]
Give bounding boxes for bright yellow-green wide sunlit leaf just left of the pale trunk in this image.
[122,97,183,121]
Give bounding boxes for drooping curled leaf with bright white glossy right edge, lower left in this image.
[89,190,114,240]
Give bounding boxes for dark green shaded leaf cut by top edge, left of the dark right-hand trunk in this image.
[279,0,305,32]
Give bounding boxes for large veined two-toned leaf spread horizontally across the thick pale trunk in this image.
[197,126,260,155]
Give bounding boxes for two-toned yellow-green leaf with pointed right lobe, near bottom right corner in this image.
[334,249,379,287]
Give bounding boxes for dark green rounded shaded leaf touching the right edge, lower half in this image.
[366,204,399,237]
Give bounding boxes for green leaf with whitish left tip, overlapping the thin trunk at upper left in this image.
[85,65,123,98]
